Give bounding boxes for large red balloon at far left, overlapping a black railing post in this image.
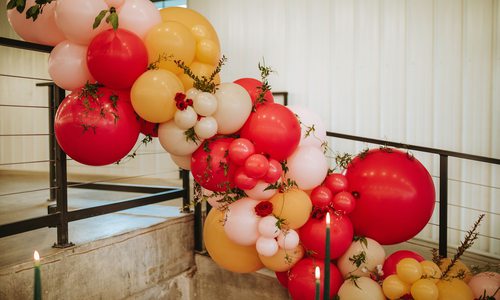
[54,88,140,166]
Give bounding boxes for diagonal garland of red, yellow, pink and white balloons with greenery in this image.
[7,0,500,299]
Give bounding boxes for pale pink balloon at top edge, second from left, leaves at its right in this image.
[55,0,111,45]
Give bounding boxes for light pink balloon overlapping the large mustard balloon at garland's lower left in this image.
[224,198,260,246]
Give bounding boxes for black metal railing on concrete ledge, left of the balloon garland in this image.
[0,37,190,248]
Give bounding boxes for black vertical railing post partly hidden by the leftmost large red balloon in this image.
[52,85,73,248]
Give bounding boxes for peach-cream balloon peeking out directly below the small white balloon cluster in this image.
[158,120,203,156]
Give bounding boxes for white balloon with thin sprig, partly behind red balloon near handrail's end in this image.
[287,105,326,148]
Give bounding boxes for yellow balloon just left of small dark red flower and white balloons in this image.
[130,69,184,123]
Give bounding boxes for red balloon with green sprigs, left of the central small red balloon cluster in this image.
[191,136,236,192]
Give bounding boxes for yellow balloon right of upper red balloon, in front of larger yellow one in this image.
[144,22,196,74]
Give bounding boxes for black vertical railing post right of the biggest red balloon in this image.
[439,154,448,257]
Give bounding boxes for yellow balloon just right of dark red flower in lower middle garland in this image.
[270,189,312,229]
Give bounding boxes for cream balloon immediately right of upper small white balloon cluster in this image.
[213,82,252,134]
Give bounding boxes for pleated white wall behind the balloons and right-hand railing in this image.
[188,0,500,256]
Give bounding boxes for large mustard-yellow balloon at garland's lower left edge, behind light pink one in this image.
[203,209,264,273]
